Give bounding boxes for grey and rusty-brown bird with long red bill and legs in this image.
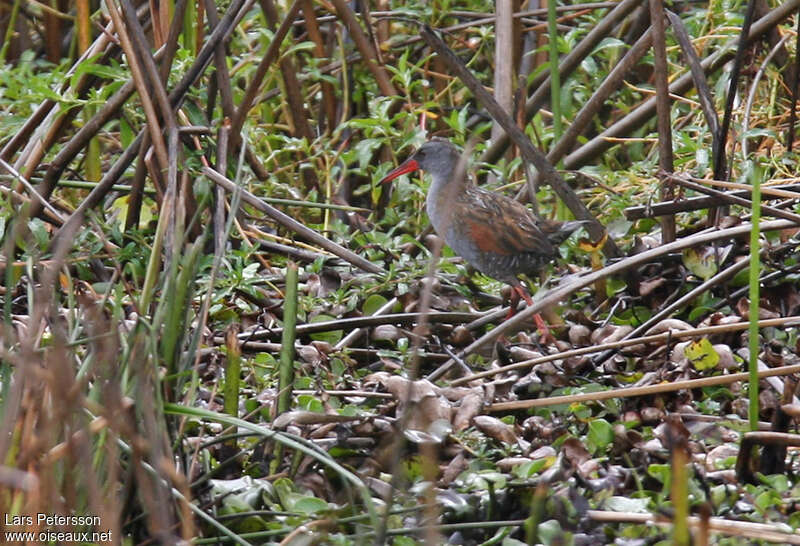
[380,137,588,339]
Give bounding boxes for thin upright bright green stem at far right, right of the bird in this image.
[748,163,763,430]
